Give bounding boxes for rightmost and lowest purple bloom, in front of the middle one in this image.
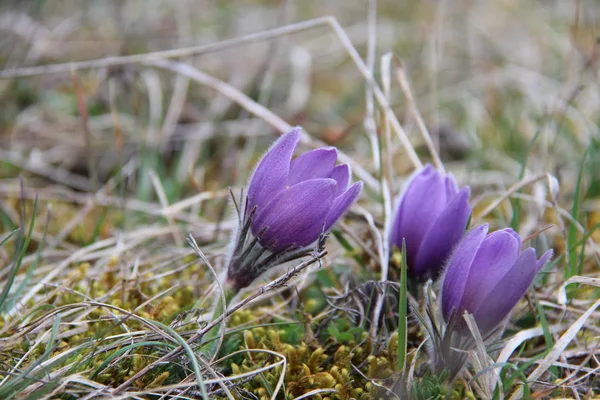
[441,224,552,337]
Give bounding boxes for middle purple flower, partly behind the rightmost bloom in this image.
[390,165,471,279]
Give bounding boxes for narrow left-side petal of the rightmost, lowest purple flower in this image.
[442,224,488,321]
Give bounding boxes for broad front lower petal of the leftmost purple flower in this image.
[252,179,336,252]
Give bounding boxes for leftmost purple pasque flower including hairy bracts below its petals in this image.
[225,127,362,290]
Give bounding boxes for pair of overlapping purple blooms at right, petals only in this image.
[390,165,552,336]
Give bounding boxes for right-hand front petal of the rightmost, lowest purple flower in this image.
[473,247,538,335]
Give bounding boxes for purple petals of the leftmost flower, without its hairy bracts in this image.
[248,128,362,252]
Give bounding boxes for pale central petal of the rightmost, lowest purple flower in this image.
[462,229,521,313]
